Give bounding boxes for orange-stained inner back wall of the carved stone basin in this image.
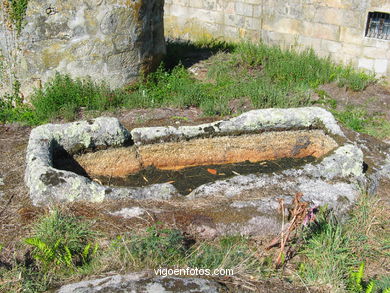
[75,130,338,177]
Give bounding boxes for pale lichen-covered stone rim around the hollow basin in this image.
[25,107,363,205]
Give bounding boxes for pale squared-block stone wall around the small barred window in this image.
[164,0,390,77]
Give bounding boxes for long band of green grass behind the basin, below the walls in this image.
[0,41,374,125]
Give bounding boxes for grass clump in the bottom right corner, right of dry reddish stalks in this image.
[298,194,390,292]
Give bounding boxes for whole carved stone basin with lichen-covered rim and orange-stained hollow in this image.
[25,107,363,219]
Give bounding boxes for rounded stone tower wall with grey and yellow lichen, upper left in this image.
[0,0,165,93]
